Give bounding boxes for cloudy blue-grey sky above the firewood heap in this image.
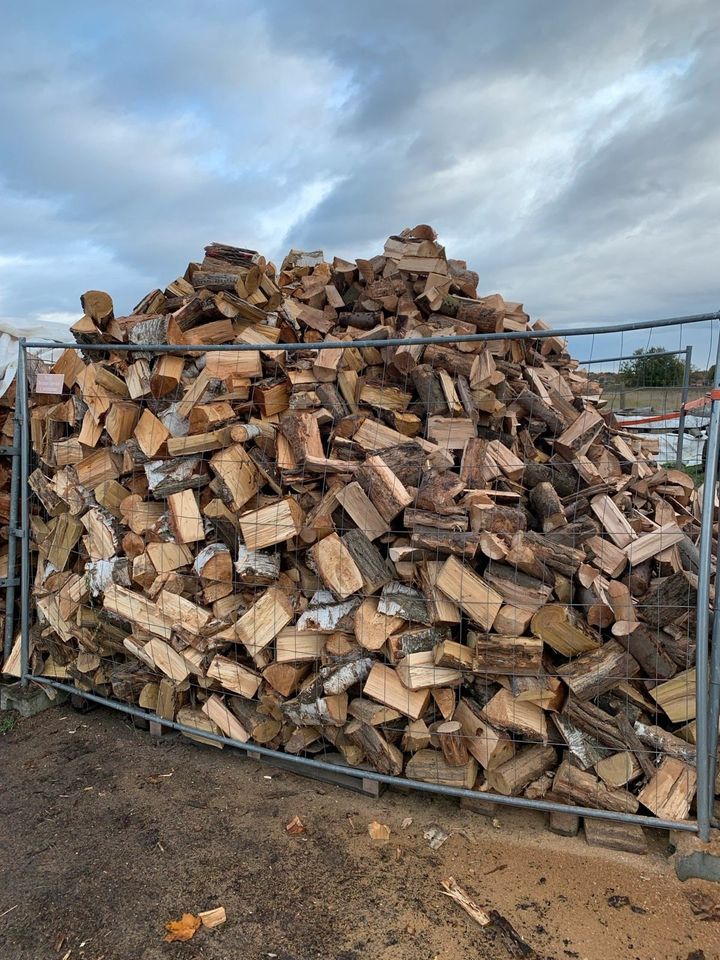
[0,0,720,367]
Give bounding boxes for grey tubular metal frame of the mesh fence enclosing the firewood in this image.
[17,312,720,840]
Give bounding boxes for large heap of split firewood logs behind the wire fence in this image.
[16,226,699,819]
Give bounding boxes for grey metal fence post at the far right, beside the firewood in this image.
[695,343,720,841]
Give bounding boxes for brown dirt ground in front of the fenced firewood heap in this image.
[0,706,720,960]
